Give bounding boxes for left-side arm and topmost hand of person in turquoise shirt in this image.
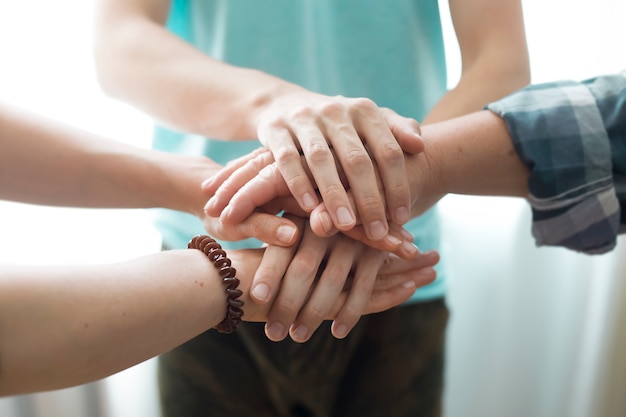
[95,0,422,240]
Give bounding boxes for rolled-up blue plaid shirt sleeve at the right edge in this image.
[487,71,626,254]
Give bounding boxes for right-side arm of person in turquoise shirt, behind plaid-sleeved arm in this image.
[423,0,530,124]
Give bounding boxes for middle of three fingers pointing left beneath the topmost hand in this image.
[204,150,274,216]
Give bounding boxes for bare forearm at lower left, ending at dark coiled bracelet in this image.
[0,250,226,395]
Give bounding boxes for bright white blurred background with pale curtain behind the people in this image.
[0,0,626,417]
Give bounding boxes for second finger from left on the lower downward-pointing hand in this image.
[265,221,329,341]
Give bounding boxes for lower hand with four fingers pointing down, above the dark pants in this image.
[243,214,438,342]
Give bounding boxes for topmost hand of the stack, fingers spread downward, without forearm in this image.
[252,90,423,240]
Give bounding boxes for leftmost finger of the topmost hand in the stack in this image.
[259,123,319,212]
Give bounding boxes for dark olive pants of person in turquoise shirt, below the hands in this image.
[159,299,448,417]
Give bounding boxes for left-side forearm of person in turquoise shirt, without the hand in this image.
[95,1,302,139]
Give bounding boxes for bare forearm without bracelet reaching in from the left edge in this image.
[0,105,211,213]
